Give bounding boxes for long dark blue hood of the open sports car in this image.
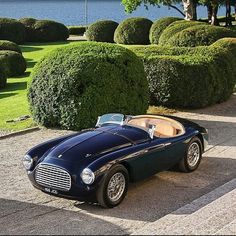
[42,126,149,165]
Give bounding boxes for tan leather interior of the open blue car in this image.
[127,115,185,138]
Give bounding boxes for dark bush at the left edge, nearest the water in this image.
[0,18,25,44]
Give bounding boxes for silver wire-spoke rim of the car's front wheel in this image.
[107,172,125,202]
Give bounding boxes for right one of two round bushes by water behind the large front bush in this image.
[114,17,152,45]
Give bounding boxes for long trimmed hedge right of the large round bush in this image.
[130,39,236,108]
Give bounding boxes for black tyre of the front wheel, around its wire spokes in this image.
[97,164,129,208]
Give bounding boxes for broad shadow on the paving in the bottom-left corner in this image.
[0,198,128,235]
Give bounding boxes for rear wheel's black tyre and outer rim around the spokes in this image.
[178,137,202,173]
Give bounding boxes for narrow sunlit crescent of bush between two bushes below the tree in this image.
[159,20,205,46]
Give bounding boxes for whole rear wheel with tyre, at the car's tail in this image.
[179,137,202,173]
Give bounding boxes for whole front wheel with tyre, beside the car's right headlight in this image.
[97,164,129,208]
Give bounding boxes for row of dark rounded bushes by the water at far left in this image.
[0,18,69,44]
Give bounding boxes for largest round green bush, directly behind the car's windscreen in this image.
[28,42,148,130]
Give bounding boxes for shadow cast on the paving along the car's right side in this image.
[74,157,236,222]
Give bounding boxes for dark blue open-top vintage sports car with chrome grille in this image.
[23,113,208,208]
